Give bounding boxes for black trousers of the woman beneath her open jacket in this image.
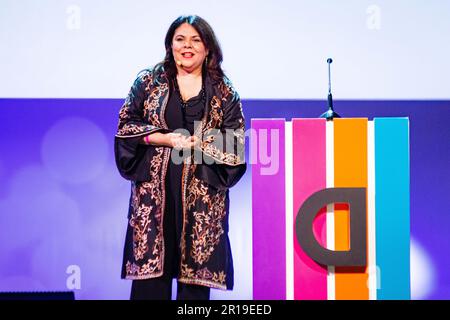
[130,172,210,300]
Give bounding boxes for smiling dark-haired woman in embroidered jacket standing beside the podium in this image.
[115,16,246,299]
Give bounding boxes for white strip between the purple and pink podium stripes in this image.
[284,121,294,300]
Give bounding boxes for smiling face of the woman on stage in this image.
[172,23,208,72]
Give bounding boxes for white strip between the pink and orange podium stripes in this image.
[326,121,336,300]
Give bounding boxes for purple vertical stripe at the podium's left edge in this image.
[250,119,286,300]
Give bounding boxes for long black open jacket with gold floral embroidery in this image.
[114,70,246,290]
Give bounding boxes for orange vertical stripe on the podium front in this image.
[334,119,369,300]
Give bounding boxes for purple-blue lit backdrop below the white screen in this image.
[0,99,450,299]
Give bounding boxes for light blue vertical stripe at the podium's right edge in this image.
[374,118,411,300]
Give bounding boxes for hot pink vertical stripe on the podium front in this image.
[292,119,327,300]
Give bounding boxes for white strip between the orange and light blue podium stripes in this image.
[367,121,378,300]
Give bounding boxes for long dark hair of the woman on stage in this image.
[153,15,224,82]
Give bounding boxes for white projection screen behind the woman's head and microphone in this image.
[0,0,450,99]
